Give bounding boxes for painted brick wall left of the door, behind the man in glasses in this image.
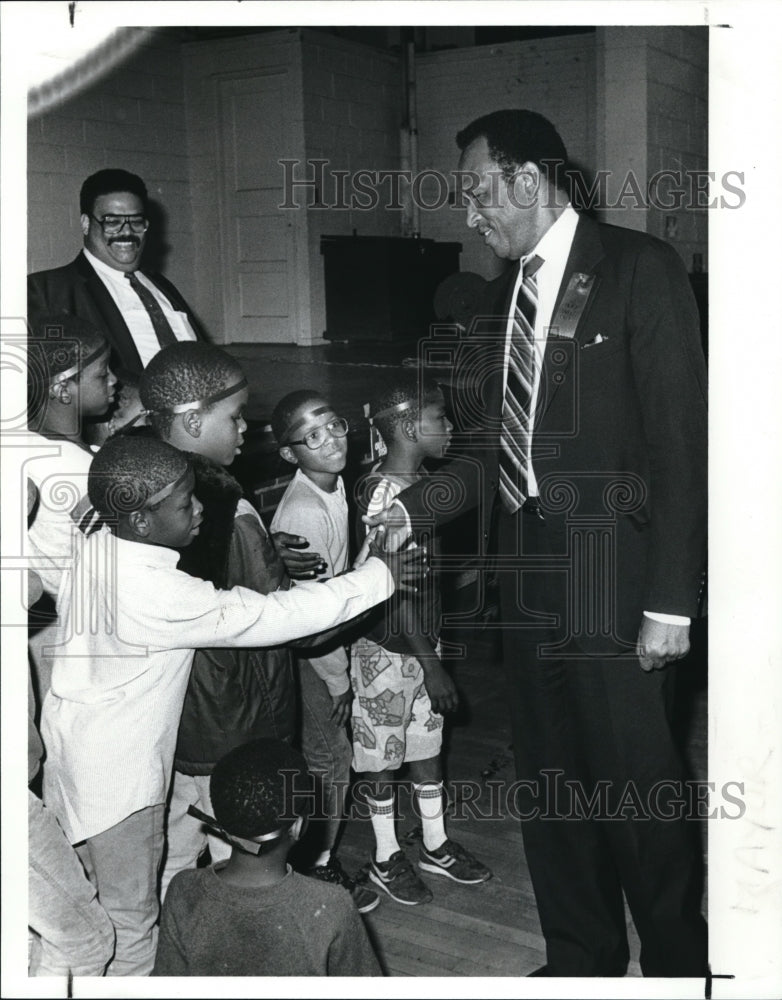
[27,32,199,310]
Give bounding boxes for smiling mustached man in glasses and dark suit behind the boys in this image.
[27,169,200,374]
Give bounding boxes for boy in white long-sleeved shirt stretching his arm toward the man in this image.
[41,435,422,975]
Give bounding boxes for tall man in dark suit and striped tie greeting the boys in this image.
[370,111,707,976]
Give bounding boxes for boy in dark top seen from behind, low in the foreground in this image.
[153,739,381,976]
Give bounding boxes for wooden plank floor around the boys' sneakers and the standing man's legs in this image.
[339,592,706,976]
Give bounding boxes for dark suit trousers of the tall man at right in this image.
[498,513,707,976]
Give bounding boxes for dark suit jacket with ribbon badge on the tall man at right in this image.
[400,217,707,639]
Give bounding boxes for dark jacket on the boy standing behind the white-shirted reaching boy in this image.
[174,455,296,774]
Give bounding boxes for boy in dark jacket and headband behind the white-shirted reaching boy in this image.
[141,343,377,912]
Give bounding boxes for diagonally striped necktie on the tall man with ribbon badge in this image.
[500,256,543,514]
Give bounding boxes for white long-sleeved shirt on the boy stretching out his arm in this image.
[41,528,394,844]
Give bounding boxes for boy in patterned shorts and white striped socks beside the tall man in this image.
[351,371,491,906]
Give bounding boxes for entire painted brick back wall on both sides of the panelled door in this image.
[28,27,708,343]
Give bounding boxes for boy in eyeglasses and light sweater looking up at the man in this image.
[271,389,378,913]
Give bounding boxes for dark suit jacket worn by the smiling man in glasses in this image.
[27,253,203,375]
